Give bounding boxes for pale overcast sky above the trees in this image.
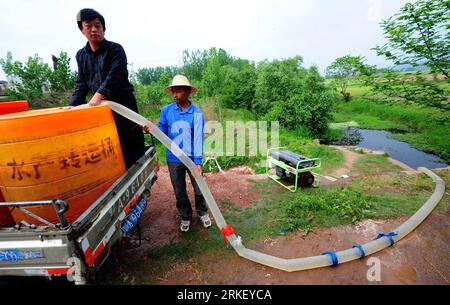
[0,0,408,80]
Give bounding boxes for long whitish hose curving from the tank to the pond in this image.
[107,102,445,272]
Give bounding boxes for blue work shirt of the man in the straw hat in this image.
[158,101,205,165]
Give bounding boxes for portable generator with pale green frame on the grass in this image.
[266,147,321,192]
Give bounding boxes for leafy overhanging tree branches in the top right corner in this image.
[374,0,450,79]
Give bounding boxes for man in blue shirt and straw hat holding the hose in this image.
[158,75,211,232]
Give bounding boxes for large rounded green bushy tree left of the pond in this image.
[252,56,338,136]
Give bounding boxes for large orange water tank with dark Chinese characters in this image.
[0,105,126,224]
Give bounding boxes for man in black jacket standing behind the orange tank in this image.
[69,8,145,169]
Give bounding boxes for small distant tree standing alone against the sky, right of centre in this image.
[326,55,375,102]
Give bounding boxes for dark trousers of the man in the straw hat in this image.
[167,162,208,220]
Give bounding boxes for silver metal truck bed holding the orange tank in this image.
[0,146,157,284]
